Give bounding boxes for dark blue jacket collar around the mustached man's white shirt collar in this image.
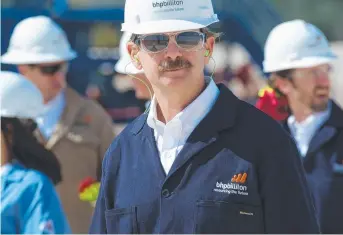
[131,84,239,138]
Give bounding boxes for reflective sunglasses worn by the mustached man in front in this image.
[133,31,206,53]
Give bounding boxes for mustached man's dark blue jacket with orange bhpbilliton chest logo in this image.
[90,85,318,233]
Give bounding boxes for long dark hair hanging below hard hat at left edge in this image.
[1,117,62,185]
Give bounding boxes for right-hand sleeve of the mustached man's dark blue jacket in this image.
[258,133,319,234]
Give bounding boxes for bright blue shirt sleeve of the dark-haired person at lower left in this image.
[23,177,71,234]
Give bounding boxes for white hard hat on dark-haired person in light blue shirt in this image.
[0,71,44,119]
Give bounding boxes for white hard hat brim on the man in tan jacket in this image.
[1,50,77,65]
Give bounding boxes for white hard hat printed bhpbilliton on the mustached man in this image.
[122,0,219,34]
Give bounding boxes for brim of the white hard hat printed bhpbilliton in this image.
[121,15,219,34]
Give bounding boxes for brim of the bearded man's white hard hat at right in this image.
[263,54,337,73]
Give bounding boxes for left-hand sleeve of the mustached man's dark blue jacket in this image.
[89,139,121,234]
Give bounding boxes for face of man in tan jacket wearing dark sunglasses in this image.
[18,61,68,103]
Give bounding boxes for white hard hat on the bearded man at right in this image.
[263,20,336,72]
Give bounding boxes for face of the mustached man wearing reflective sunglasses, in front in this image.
[128,30,215,89]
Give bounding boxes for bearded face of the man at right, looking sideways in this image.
[280,64,330,112]
